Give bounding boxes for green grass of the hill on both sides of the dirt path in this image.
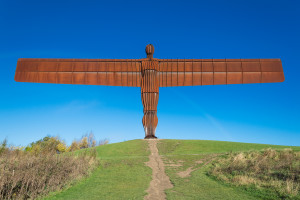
[45,140,300,200]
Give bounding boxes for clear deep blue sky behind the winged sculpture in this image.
[0,0,300,146]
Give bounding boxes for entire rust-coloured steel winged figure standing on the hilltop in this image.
[15,44,284,138]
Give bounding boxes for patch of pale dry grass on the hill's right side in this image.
[210,148,300,199]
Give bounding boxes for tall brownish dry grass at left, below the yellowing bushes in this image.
[0,144,98,199]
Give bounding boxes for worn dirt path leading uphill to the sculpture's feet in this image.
[144,139,173,200]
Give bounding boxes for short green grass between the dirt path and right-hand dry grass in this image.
[158,140,300,200]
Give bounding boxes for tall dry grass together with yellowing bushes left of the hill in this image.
[0,132,108,199]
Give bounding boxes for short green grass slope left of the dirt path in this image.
[45,140,152,200]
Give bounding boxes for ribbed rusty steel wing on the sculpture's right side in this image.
[159,59,284,87]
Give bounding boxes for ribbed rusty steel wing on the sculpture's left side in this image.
[15,58,141,87]
